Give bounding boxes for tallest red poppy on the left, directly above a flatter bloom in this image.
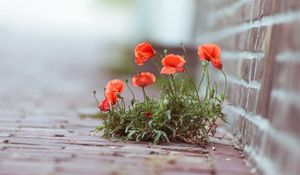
[135,42,156,66]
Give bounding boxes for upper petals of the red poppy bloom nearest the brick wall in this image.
[198,43,221,61]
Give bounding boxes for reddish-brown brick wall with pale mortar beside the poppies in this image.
[194,0,300,175]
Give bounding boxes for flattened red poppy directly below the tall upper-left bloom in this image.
[132,72,156,87]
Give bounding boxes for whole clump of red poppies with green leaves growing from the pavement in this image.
[94,42,227,146]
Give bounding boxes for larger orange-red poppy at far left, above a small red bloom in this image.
[105,79,124,105]
